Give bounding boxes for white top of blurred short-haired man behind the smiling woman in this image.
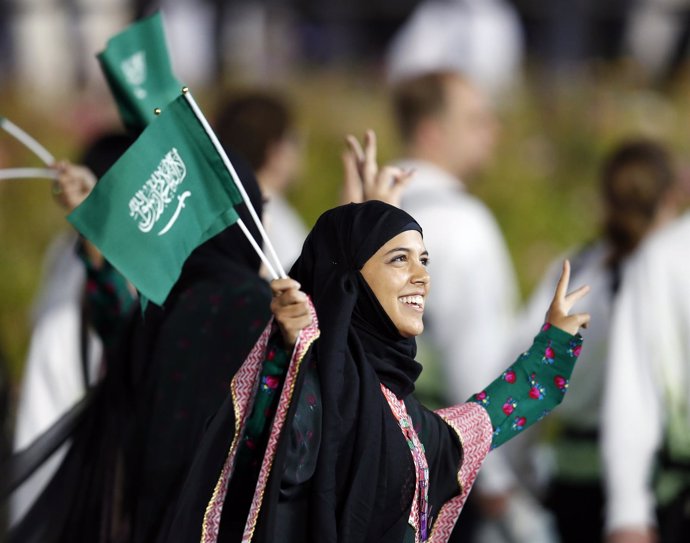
[398,157,520,493]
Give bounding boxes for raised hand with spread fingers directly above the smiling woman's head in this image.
[342,130,414,207]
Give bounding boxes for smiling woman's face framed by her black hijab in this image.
[362,230,430,337]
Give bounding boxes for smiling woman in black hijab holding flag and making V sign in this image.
[166,201,587,543]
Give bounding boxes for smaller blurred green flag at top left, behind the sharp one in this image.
[97,12,182,131]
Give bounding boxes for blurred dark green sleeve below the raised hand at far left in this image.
[77,238,136,347]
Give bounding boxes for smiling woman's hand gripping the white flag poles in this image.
[271,277,312,347]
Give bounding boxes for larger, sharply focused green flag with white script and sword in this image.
[67,96,242,305]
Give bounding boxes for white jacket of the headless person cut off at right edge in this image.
[603,214,690,531]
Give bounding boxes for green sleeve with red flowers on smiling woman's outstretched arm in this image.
[470,323,582,449]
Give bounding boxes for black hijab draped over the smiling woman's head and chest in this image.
[256,201,422,543]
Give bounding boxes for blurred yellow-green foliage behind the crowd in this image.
[0,66,690,384]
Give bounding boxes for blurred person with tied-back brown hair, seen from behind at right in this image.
[515,139,678,543]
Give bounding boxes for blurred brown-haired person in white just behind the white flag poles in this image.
[215,90,307,269]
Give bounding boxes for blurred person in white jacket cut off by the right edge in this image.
[602,154,690,543]
